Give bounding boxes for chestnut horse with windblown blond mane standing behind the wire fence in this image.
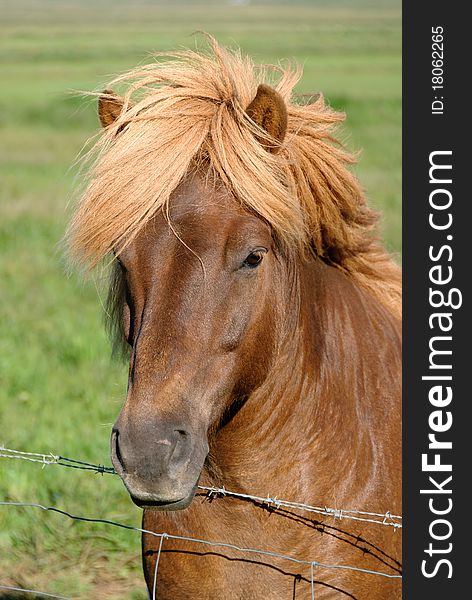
[67,37,401,600]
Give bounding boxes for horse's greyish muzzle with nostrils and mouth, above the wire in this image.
[111,423,208,511]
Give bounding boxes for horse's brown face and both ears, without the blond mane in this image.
[99,85,287,510]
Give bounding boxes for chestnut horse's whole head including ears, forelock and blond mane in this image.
[68,40,400,520]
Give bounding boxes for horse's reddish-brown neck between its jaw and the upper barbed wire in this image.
[208,261,399,498]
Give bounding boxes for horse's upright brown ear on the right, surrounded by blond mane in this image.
[246,83,287,152]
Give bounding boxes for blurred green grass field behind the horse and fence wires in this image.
[0,0,401,600]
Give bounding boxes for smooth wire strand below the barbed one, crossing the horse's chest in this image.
[0,502,402,579]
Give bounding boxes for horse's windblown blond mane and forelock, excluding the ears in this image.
[67,37,401,316]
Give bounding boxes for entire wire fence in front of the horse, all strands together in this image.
[0,446,402,600]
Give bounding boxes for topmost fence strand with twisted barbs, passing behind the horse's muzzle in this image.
[0,446,402,530]
